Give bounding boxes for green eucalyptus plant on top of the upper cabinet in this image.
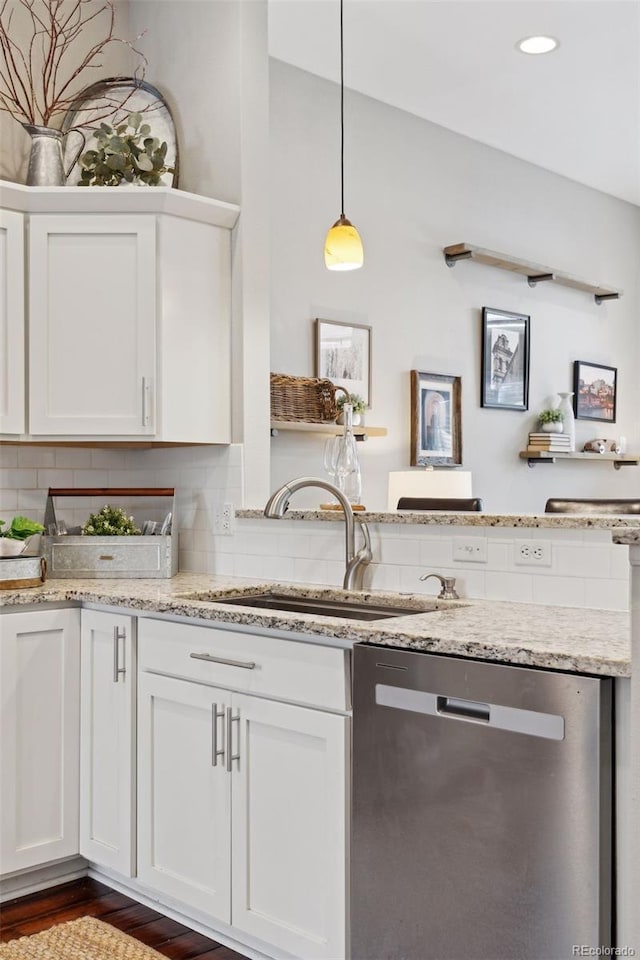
[78,113,174,187]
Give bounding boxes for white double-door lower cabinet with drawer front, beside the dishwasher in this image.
[138,618,350,960]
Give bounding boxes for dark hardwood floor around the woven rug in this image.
[0,877,250,960]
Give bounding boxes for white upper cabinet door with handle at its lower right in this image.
[29,214,156,437]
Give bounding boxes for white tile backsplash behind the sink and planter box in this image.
[0,444,629,610]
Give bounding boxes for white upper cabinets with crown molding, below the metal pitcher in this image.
[0,184,238,443]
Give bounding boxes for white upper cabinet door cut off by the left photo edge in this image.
[0,210,25,434]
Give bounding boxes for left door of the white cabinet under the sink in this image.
[138,673,232,923]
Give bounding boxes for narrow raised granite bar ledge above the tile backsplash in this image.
[236,508,640,528]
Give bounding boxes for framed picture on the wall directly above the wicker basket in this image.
[316,319,371,407]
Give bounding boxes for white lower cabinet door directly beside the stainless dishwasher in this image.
[231,694,349,960]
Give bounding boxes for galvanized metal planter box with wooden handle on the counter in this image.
[43,487,178,580]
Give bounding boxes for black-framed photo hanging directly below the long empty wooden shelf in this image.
[480,307,530,410]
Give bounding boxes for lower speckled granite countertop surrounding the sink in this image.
[0,572,640,676]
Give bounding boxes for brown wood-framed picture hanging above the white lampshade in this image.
[411,370,462,467]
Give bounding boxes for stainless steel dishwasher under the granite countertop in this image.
[351,645,612,960]
